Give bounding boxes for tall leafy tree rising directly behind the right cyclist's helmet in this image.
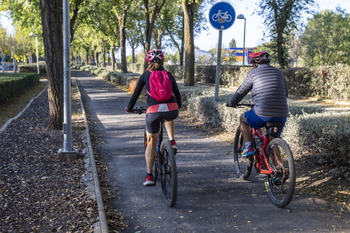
[257,0,314,68]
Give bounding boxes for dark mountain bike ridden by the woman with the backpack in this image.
[132,106,177,207]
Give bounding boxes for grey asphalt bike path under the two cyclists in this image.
[72,71,350,233]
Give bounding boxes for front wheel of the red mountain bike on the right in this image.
[233,126,254,180]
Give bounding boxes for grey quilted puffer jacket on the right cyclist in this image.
[229,64,288,117]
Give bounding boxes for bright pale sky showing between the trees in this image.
[0,0,350,51]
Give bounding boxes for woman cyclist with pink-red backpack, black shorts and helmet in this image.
[126,49,181,186]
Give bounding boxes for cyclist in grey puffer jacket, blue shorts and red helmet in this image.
[226,51,288,157]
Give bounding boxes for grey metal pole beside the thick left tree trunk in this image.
[62,0,76,158]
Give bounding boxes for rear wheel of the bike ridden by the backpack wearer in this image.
[160,140,177,207]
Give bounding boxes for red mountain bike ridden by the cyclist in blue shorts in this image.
[233,104,296,208]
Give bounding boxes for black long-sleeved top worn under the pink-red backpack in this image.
[127,70,181,110]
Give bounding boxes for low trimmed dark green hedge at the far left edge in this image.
[0,73,39,104]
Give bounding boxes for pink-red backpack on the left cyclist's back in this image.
[147,70,173,102]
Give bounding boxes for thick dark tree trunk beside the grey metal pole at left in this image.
[40,0,63,130]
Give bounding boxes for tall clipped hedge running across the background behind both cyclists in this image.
[128,64,350,101]
